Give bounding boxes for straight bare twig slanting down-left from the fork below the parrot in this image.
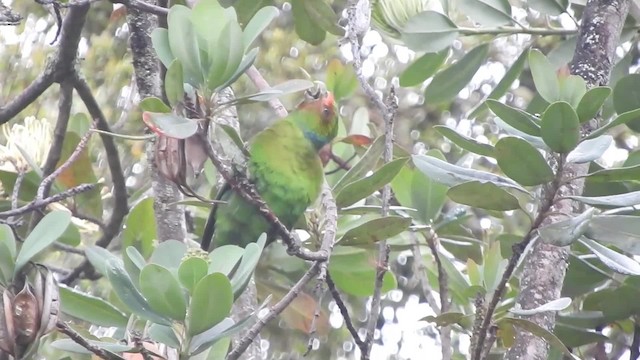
[227,261,320,360]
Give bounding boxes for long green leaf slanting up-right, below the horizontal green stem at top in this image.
[424,44,489,104]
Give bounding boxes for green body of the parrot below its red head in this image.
[214,121,323,247]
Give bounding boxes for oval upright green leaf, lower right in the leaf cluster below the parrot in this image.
[187,273,233,336]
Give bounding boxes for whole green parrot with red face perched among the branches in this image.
[201,90,338,251]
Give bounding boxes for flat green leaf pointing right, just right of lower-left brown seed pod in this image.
[59,285,128,328]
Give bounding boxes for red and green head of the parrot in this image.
[296,87,338,150]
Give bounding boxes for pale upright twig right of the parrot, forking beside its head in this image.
[347,0,398,360]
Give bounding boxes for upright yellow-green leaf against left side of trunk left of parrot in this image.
[122,197,158,258]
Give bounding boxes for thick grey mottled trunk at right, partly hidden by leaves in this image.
[505,0,629,360]
